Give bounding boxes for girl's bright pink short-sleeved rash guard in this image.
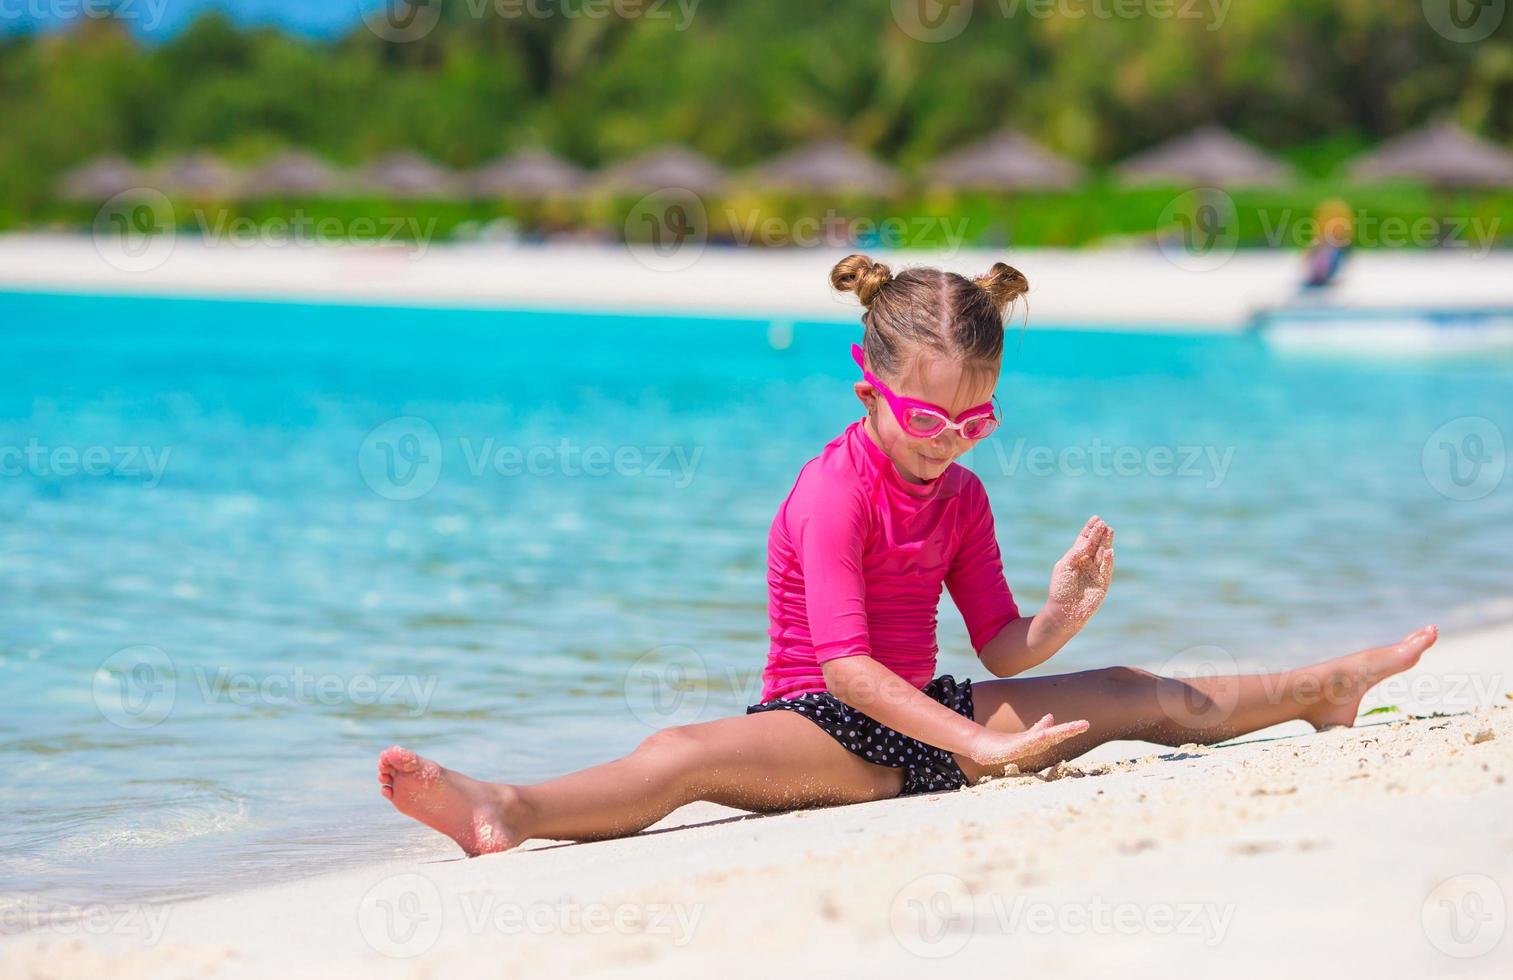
[761,422,1020,702]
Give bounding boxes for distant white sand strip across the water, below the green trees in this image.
[0,234,1513,331]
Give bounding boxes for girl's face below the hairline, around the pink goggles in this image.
[856,355,999,482]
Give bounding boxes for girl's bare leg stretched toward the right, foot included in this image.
[956,626,1439,780]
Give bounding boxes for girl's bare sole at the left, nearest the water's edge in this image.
[378,746,525,858]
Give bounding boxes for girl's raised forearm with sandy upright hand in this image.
[977,516,1114,678]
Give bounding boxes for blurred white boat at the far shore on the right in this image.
[1251,305,1513,357]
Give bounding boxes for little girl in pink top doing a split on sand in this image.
[378,256,1437,854]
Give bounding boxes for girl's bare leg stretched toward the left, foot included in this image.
[378,711,903,854]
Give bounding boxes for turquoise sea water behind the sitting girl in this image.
[0,287,1513,904]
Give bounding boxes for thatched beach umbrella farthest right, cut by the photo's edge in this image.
[1350,121,1513,188]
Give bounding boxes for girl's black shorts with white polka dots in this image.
[746,675,971,795]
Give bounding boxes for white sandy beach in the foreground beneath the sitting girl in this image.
[0,626,1513,978]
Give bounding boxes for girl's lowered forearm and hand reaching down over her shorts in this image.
[823,656,1088,765]
